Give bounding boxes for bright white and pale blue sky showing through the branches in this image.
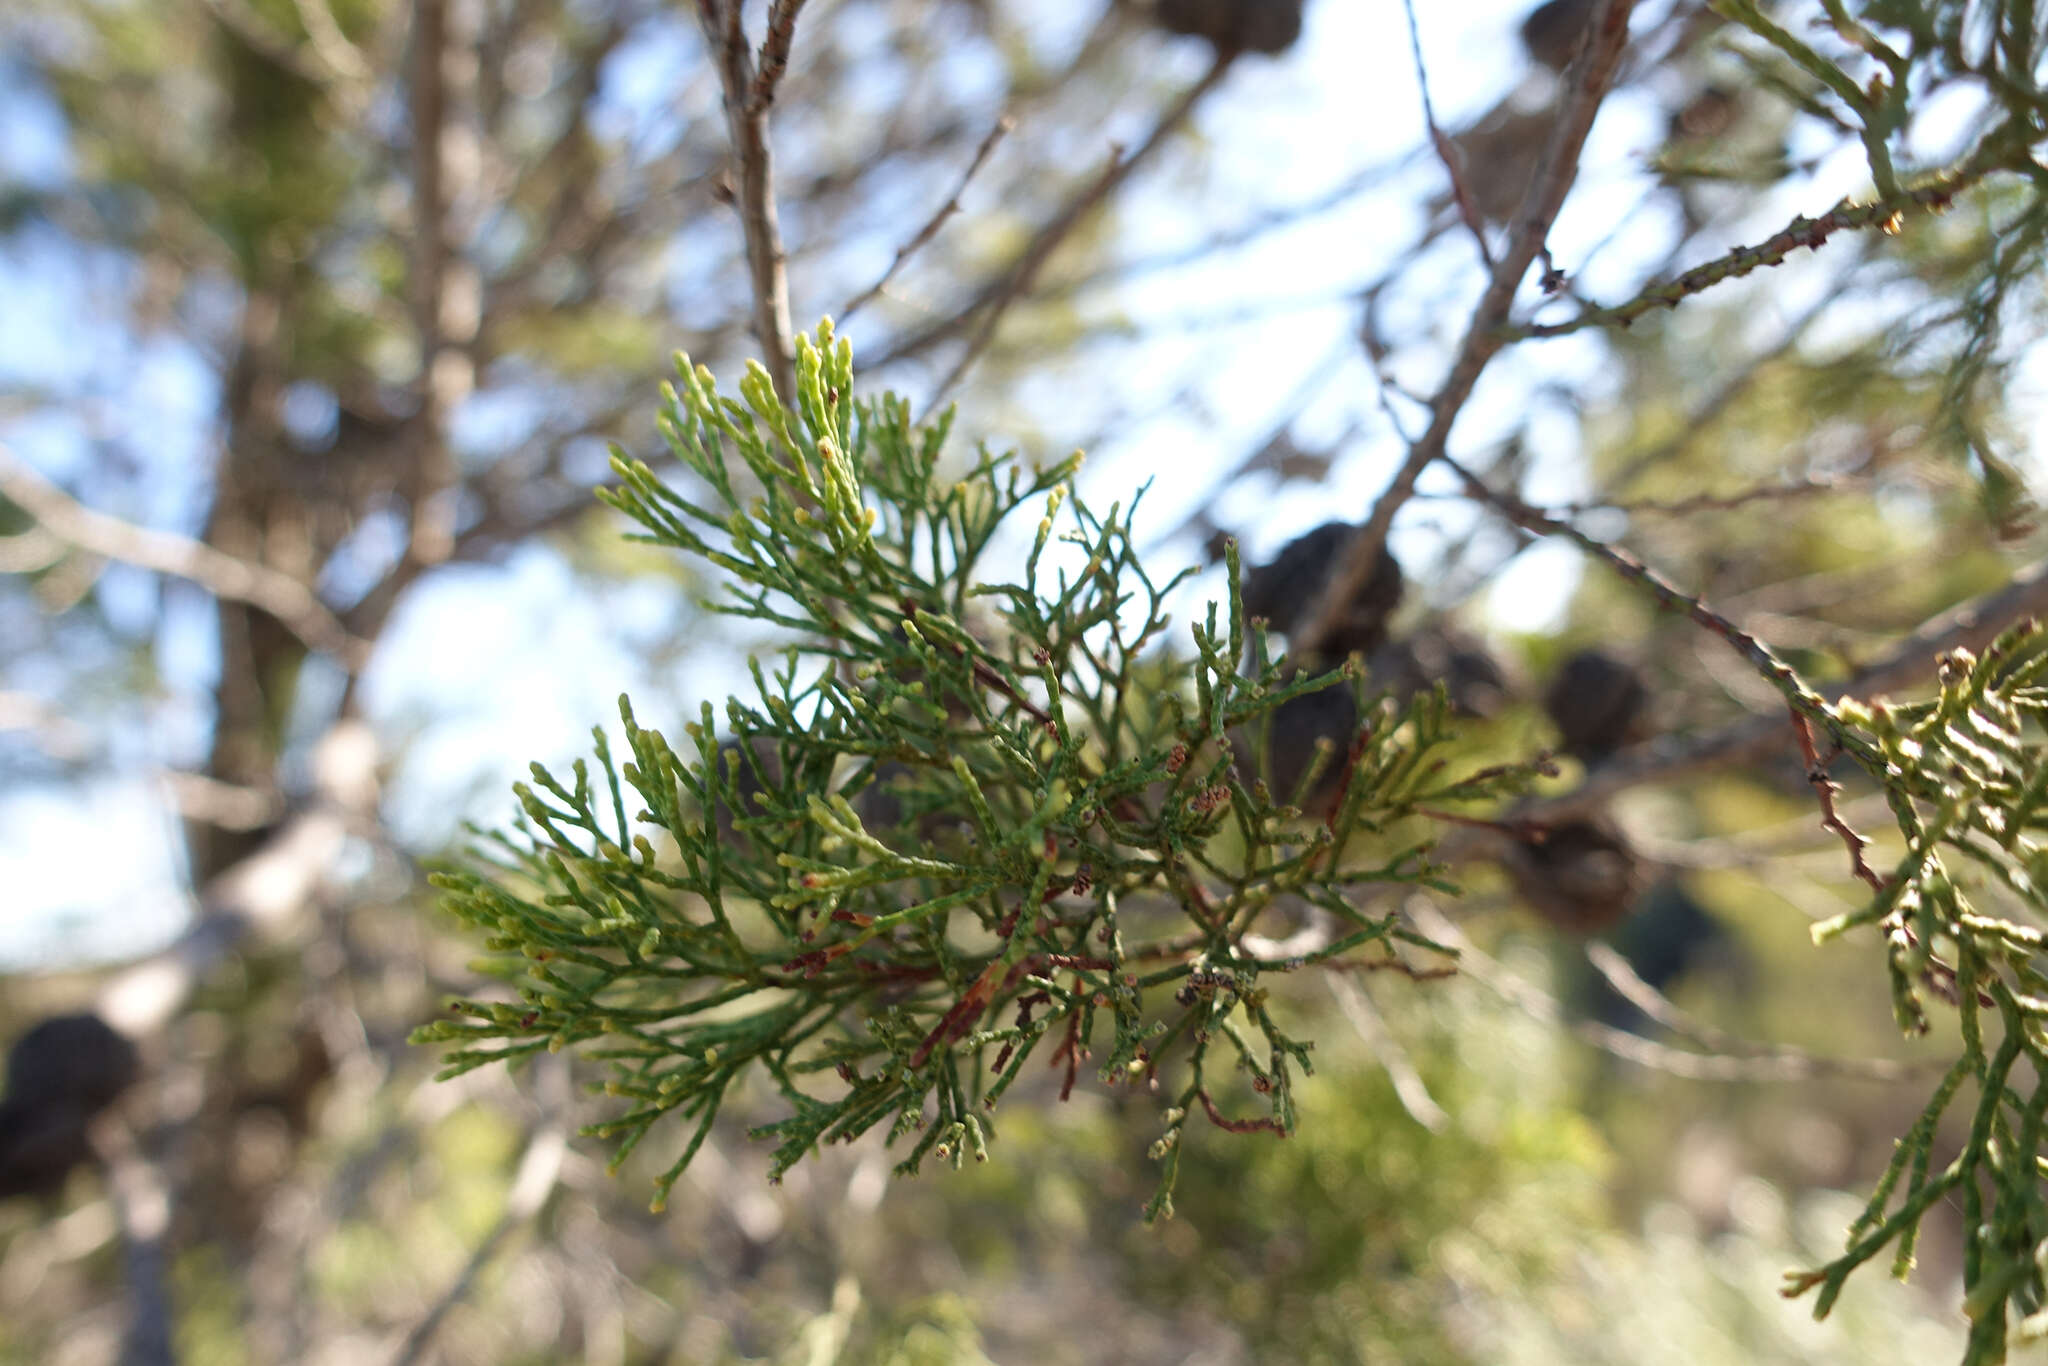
[0,0,2048,971]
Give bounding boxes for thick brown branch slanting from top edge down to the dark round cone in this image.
[1292,0,1634,653]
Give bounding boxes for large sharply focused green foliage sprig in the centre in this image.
[407,324,1534,1212]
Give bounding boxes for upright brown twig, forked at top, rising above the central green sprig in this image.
[696,0,803,403]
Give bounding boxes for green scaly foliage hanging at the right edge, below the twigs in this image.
[1788,621,2048,1366]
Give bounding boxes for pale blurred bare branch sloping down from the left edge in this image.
[0,444,371,670]
